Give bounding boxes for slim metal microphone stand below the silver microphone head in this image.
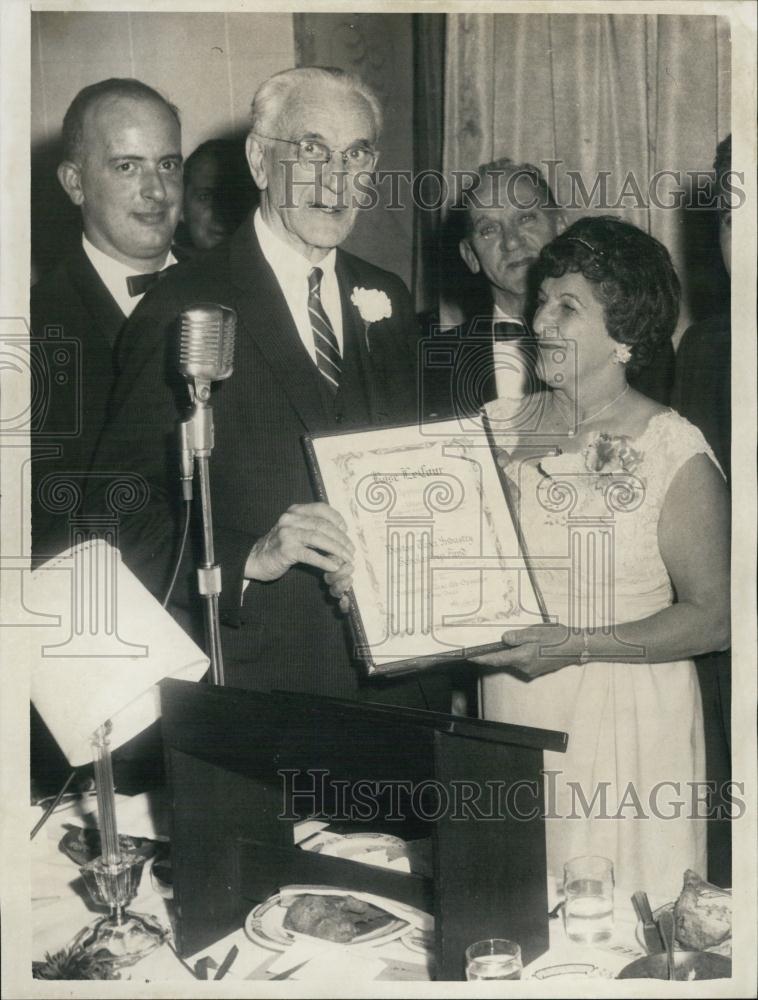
[181,378,224,687]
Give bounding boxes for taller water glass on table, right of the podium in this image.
[563,856,613,944]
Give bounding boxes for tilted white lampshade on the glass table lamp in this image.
[29,539,208,767]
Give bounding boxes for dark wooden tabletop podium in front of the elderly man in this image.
[161,680,568,980]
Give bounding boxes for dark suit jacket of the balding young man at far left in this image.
[31,246,125,559]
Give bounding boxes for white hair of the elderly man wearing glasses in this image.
[250,66,382,139]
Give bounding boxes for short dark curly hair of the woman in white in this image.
[535,215,680,373]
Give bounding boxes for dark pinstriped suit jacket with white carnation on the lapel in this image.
[97,219,452,707]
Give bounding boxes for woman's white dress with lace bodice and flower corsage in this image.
[482,410,716,898]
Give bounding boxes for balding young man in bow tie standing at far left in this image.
[31,79,182,558]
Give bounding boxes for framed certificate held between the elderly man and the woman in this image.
[305,420,547,673]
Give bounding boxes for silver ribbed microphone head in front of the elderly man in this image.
[179,302,237,382]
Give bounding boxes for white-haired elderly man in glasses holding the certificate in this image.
[98,67,449,709]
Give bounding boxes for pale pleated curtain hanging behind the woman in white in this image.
[441,14,730,333]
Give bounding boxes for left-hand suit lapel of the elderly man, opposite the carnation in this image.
[229,223,326,429]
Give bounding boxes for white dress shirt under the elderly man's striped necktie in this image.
[253,209,344,365]
